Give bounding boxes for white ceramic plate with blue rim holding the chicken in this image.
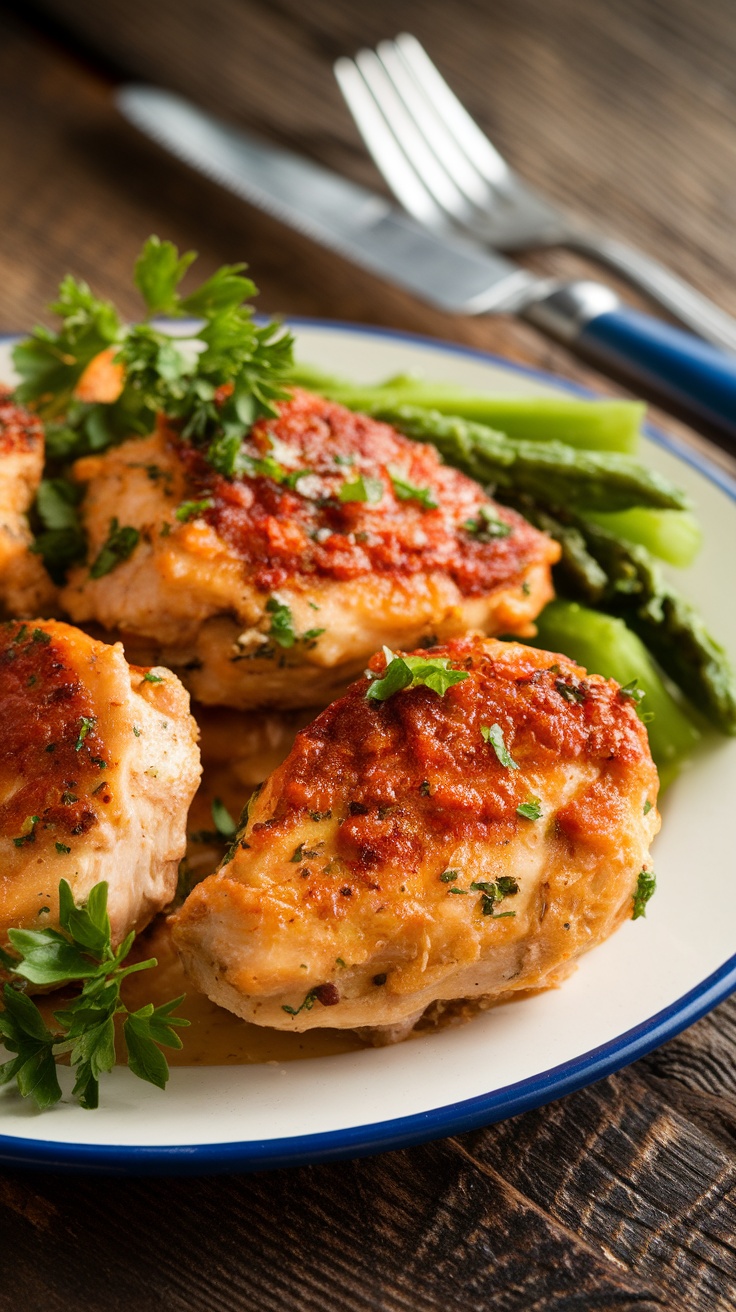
[0,320,736,1172]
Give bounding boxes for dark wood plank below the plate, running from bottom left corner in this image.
[0,1141,666,1312]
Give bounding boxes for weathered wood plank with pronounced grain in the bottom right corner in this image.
[470,1070,736,1312]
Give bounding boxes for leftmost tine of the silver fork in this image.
[335,58,445,228]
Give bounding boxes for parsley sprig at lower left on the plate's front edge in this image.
[0,879,189,1111]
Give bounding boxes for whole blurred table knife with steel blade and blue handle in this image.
[117,85,736,438]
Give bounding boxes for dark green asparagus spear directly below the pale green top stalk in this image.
[377,405,687,510]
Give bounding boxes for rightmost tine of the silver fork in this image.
[377,41,495,209]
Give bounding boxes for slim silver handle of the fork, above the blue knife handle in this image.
[565,232,736,352]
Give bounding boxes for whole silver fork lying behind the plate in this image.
[335,33,736,350]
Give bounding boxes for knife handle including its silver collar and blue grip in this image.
[525,282,736,441]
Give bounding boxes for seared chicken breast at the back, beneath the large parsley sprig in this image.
[62,391,559,708]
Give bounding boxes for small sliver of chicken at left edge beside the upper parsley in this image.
[0,391,56,618]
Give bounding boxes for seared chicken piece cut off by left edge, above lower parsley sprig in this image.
[0,621,199,942]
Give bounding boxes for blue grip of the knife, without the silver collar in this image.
[577,306,736,438]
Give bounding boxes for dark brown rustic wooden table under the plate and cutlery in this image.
[0,0,736,1312]
